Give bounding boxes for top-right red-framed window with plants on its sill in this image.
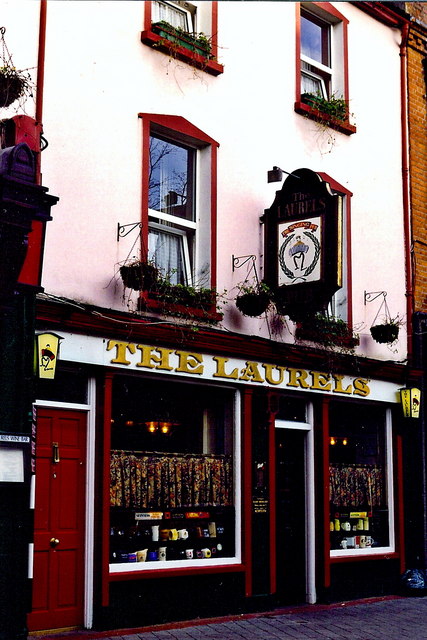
[295,2,356,135]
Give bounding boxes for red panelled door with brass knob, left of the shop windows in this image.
[28,409,86,631]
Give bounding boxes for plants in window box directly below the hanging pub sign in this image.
[295,313,359,350]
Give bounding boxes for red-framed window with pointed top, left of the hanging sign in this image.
[139,113,218,288]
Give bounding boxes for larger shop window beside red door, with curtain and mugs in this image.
[110,377,238,572]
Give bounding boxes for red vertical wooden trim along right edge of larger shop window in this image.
[241,388,253,597]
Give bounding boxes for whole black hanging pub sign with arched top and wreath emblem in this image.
[262,169,342,319]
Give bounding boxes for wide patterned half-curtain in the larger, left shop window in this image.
[110,451,233,509]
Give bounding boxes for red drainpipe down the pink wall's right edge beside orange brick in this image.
[400,22,414,362]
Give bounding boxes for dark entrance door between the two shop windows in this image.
[276,428,306,603]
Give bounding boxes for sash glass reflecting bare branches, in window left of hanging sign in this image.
[148,136,197,285]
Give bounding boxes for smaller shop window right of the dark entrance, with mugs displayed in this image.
[329,403,394,556]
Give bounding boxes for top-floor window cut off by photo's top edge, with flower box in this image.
[141,0,224,76]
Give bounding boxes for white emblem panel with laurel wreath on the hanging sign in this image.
[278,217,322,286]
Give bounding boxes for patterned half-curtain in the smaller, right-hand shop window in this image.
[329,464,385,507]
